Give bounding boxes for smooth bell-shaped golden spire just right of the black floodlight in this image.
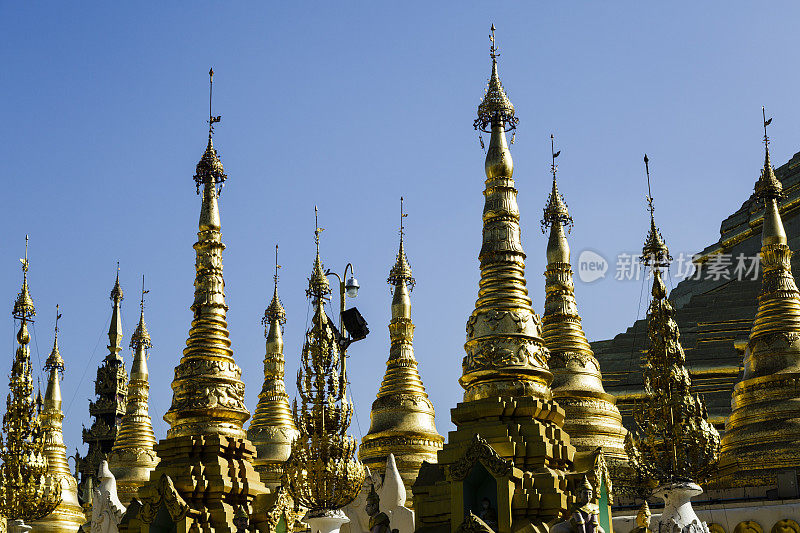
[358,197,444,501]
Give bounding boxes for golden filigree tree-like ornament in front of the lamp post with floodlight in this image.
[286,207,365,529]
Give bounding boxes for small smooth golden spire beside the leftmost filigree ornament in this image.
[35,305,86,533]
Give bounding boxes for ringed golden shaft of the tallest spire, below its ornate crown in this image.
[460,123,552,401]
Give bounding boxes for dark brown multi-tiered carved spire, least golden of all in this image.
[78,262,128,494]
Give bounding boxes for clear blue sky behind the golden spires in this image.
[0,2,800,458]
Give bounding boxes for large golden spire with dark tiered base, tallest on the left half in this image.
[130,70,269,533]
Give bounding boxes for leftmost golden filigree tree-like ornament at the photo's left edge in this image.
[0,241,61,527]
